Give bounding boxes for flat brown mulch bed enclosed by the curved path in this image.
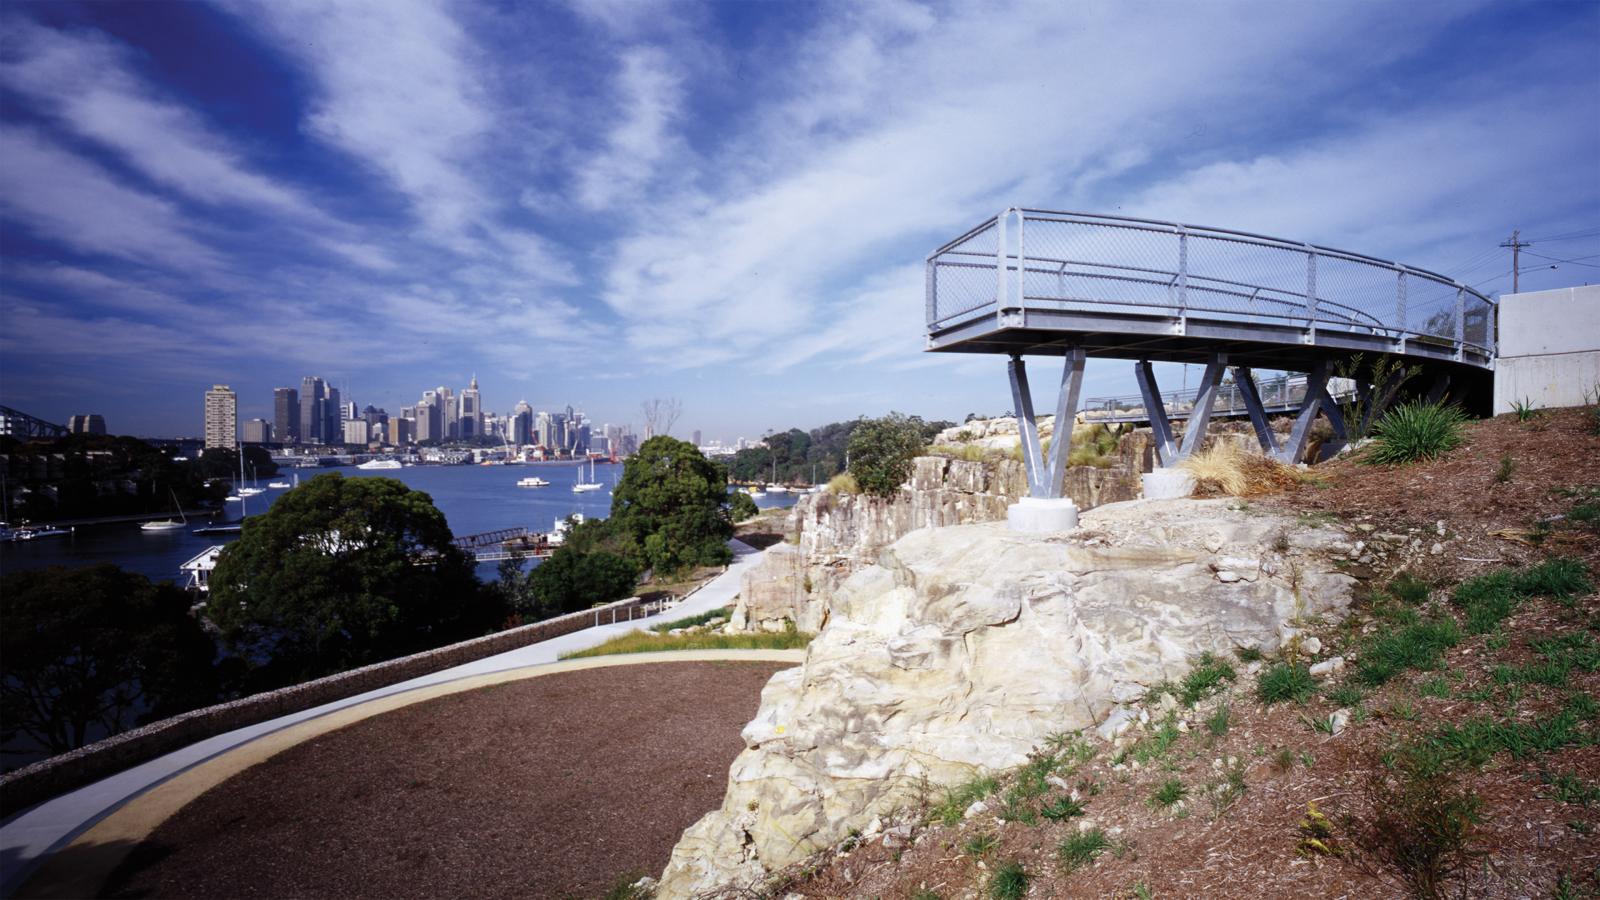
[106,663,786,897]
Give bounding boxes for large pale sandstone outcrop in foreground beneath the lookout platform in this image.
[661,500,1354,897]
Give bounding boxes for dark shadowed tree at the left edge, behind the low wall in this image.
[0,562,216,753]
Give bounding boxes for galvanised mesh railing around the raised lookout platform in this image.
[926,210,1494,359]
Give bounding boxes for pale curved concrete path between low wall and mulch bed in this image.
[0,540,774,897]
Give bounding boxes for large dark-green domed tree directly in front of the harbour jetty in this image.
[206,472,504,687]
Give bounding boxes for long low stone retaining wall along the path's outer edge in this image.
[0,597,640,817]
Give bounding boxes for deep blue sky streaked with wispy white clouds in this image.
[0,0,1600,439]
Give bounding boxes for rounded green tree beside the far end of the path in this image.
[611,436,733,573]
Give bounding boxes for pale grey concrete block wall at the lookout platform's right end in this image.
[1494,285,1600,415]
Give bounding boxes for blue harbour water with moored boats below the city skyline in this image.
[0,463,797,583]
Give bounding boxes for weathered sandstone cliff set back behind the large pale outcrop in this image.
[733,436,1147,631]
